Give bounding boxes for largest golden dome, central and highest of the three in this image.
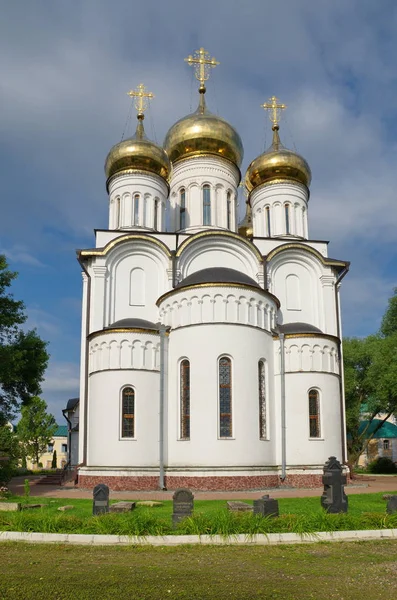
[164,92,244,167]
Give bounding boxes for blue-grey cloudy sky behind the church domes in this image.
[0,0,397,422]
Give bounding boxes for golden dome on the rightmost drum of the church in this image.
[245,125,312,192]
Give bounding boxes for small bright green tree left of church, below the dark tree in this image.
[17,396,57,465]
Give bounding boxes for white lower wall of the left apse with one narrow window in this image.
[87,370,159,468]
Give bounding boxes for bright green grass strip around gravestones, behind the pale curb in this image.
[0,493,397,536]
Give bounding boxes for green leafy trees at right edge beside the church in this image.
[343,288,397,467]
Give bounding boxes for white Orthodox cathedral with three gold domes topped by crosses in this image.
[73,48,348,490]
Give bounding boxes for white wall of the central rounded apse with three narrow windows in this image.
[168,324,277,474]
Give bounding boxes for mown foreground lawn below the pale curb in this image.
[0,541,397,600]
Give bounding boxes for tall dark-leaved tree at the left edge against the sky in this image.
[0,255,48,426]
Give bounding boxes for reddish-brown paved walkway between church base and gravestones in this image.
[8,475,397,500]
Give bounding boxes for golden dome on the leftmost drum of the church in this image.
[105,114,171,180]
